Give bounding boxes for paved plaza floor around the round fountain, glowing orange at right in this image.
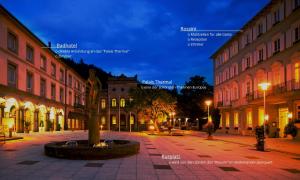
[0,131,300,180]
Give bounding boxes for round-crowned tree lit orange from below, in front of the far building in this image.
[129,86,176,131]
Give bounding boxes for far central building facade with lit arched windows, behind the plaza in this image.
[99,75,146,131]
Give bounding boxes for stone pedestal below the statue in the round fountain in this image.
[88,108,100,146]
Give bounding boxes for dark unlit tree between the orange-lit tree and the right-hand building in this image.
[177,75,213,129]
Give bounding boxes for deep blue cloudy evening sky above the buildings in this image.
[0,0,269,85]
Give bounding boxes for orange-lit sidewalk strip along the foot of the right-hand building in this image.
[189,131,300,156]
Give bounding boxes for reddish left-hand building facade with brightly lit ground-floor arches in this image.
[0,6,85,135]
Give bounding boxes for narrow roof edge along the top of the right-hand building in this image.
[210,0,280,59]
